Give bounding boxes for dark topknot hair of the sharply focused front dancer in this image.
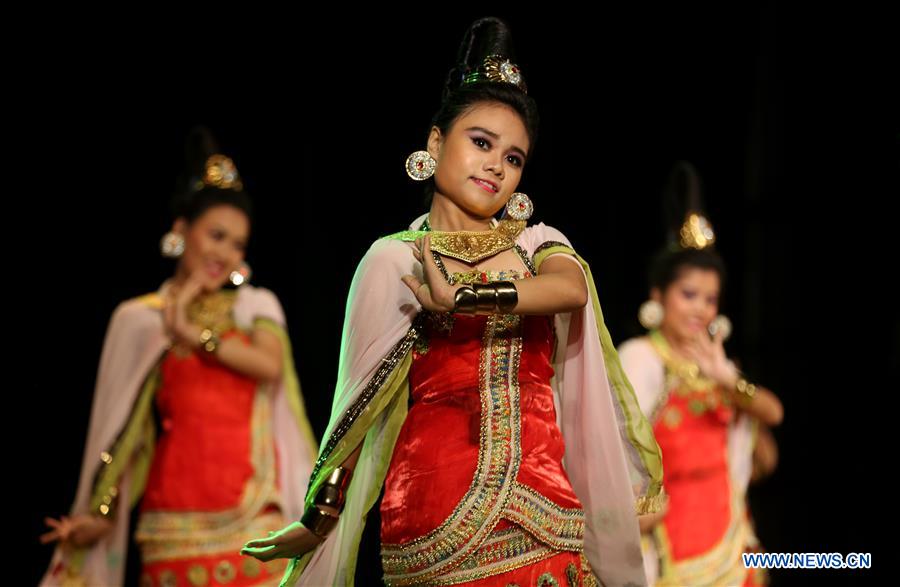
[425,17,539,201]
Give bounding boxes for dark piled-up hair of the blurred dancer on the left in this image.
[172,127,253,224]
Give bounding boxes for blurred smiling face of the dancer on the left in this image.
[175,204,250,292]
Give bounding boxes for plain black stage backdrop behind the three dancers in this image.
[12,7,900,585]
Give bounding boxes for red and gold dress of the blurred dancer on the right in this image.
[651,336,765,585]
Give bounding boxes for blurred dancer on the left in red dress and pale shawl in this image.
[42,131,317,586]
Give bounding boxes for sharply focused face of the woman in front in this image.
[428,102,530,218]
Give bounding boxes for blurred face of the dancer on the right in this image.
[651,267,720,340]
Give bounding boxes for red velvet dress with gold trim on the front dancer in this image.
[381,272,593,585]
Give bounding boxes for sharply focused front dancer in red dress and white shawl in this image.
[245,19,661,585]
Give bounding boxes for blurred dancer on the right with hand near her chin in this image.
[619,163,783,585]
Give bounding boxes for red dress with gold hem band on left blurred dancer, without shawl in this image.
[136,331,284,587]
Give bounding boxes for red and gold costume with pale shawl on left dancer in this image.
[42,285,316,587]
